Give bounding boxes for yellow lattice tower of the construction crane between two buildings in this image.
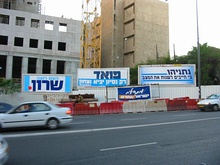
[80,0,101,68]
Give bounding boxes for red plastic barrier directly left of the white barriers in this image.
[99,102,123,114]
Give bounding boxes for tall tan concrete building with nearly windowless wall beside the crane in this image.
[101,0,169,67]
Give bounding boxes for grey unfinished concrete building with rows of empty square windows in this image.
[0,0,81,88]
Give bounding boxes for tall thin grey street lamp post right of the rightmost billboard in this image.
[196,0,201,99]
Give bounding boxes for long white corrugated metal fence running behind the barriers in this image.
[0,85,220,105]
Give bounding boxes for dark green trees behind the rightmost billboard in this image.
[130,43,220,85]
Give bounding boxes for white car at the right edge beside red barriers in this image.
[197,94,220,111]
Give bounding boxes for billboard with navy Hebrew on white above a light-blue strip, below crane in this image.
[77,68,130,87]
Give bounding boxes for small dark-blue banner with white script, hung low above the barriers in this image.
[118,85,151,101]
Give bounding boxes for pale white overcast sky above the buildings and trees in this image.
[42,0,220,56]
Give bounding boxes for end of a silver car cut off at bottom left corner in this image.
[0,135,9,165]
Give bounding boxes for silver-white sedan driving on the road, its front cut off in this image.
[0,101,72,129]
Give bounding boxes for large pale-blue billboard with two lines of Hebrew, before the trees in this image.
[138,64,196,85]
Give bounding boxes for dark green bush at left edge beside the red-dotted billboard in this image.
[0,78,21,94]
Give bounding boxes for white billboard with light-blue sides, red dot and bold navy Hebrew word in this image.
[22,74,72,93]
